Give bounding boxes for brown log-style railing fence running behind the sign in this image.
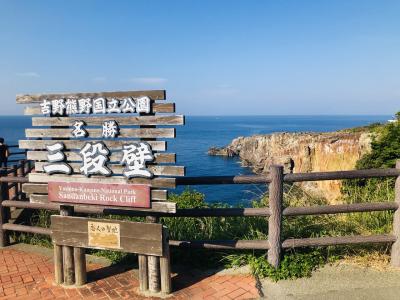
[0,162,400,267]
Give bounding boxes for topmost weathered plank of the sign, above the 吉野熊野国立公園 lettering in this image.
[16,90,166,104]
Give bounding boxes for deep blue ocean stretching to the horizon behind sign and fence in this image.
[0,115,390,206]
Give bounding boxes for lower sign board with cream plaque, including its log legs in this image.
[51,216,171,294]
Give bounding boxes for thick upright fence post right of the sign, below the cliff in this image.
[268,165,283,268]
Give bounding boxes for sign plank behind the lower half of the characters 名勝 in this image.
[25,128,175,141]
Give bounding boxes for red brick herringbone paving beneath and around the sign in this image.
[0,247,259,300]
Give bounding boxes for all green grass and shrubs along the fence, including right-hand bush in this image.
[14,113,400,280]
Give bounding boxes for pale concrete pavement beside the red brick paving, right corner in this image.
[262,264,400,300]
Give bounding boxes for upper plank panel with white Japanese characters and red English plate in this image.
[17,90,185,213]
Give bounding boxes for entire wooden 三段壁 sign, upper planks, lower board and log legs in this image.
[17,90,185,293]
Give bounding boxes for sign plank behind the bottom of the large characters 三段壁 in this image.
[35,162,185,176]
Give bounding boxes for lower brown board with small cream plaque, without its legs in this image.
[51,215,165,256]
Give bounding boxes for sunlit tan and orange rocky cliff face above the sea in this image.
[209,132,371,202]
